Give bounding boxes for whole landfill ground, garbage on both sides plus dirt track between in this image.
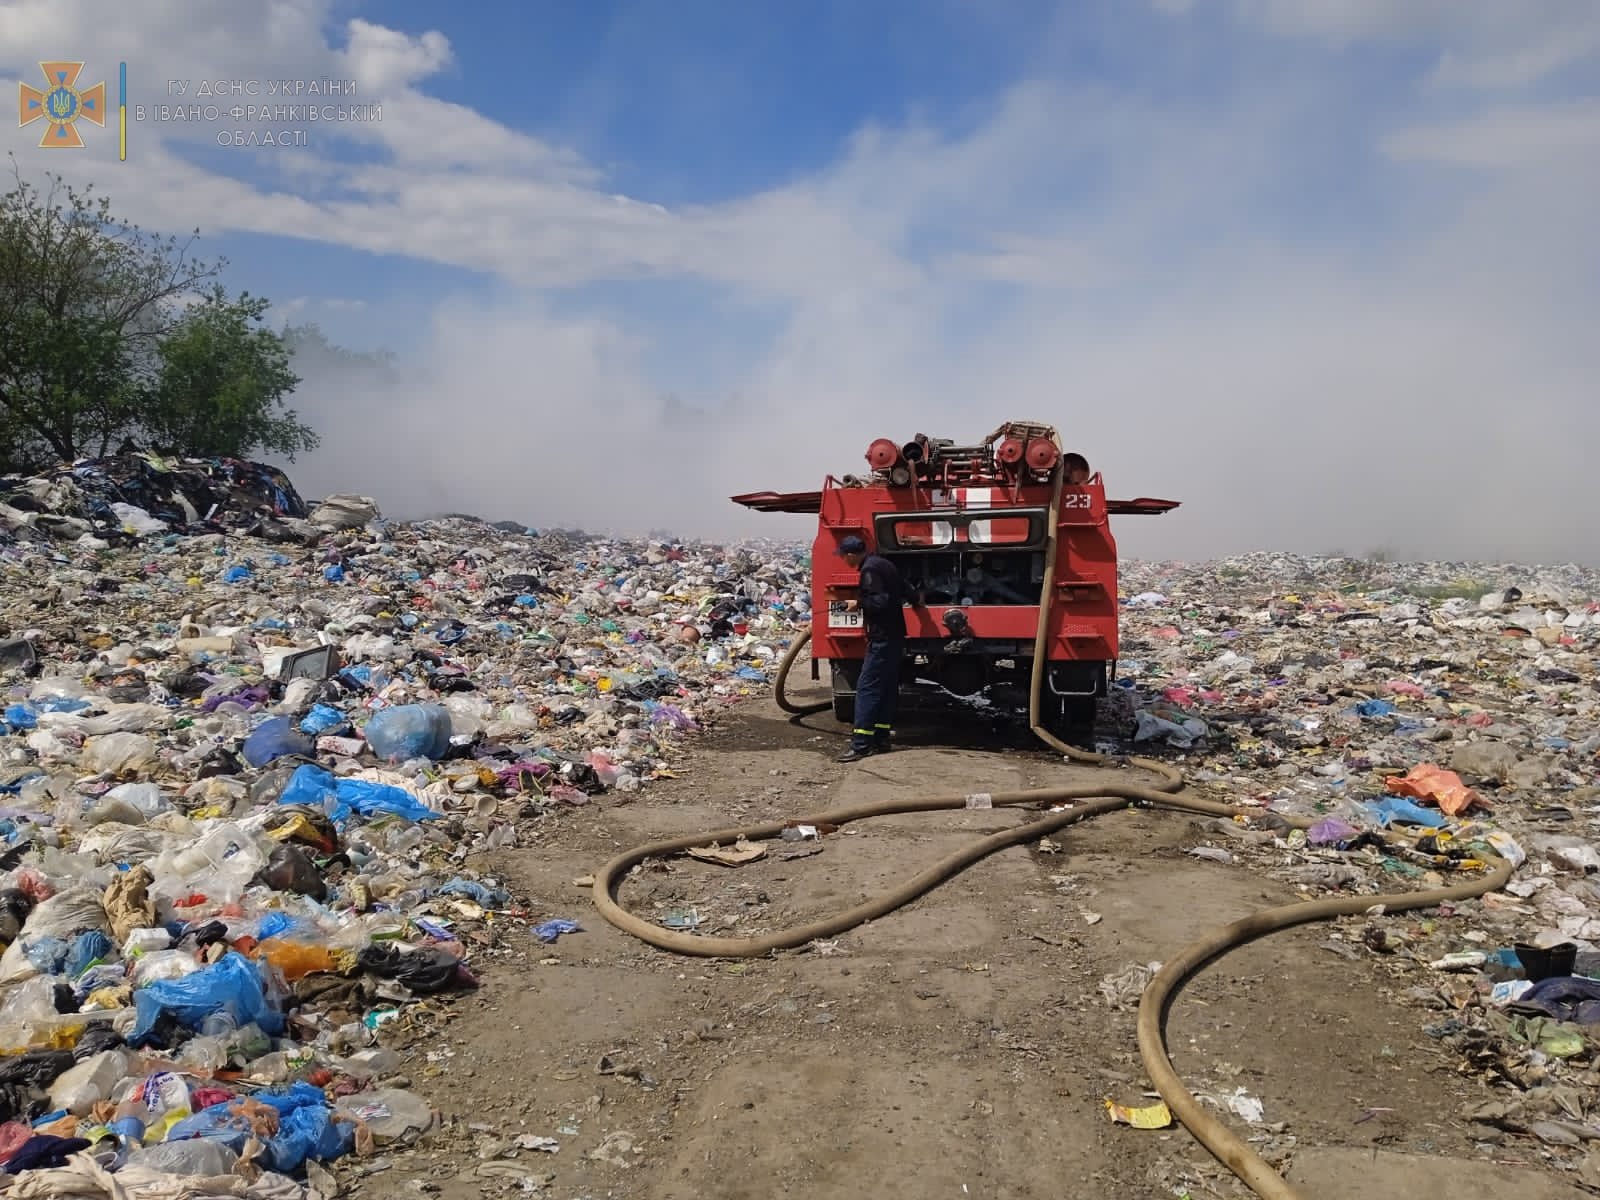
[0,458,1600,1200]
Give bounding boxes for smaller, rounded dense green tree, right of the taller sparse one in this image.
[141,288,318,462]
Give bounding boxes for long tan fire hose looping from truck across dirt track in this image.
[592,483,1512,1200]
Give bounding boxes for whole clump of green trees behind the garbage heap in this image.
[0,160,317,470]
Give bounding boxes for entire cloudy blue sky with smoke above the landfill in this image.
[0,0,1600,558]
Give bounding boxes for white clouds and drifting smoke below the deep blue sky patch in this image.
[0,0,1600,558]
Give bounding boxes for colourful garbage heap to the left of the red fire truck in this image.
[0,459,808,1197]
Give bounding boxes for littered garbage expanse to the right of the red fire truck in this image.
[1101,555,1600,1187]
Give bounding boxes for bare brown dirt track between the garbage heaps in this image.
[339,701,1576,1200]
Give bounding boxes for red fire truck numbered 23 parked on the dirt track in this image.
[733,422,1178,734]
